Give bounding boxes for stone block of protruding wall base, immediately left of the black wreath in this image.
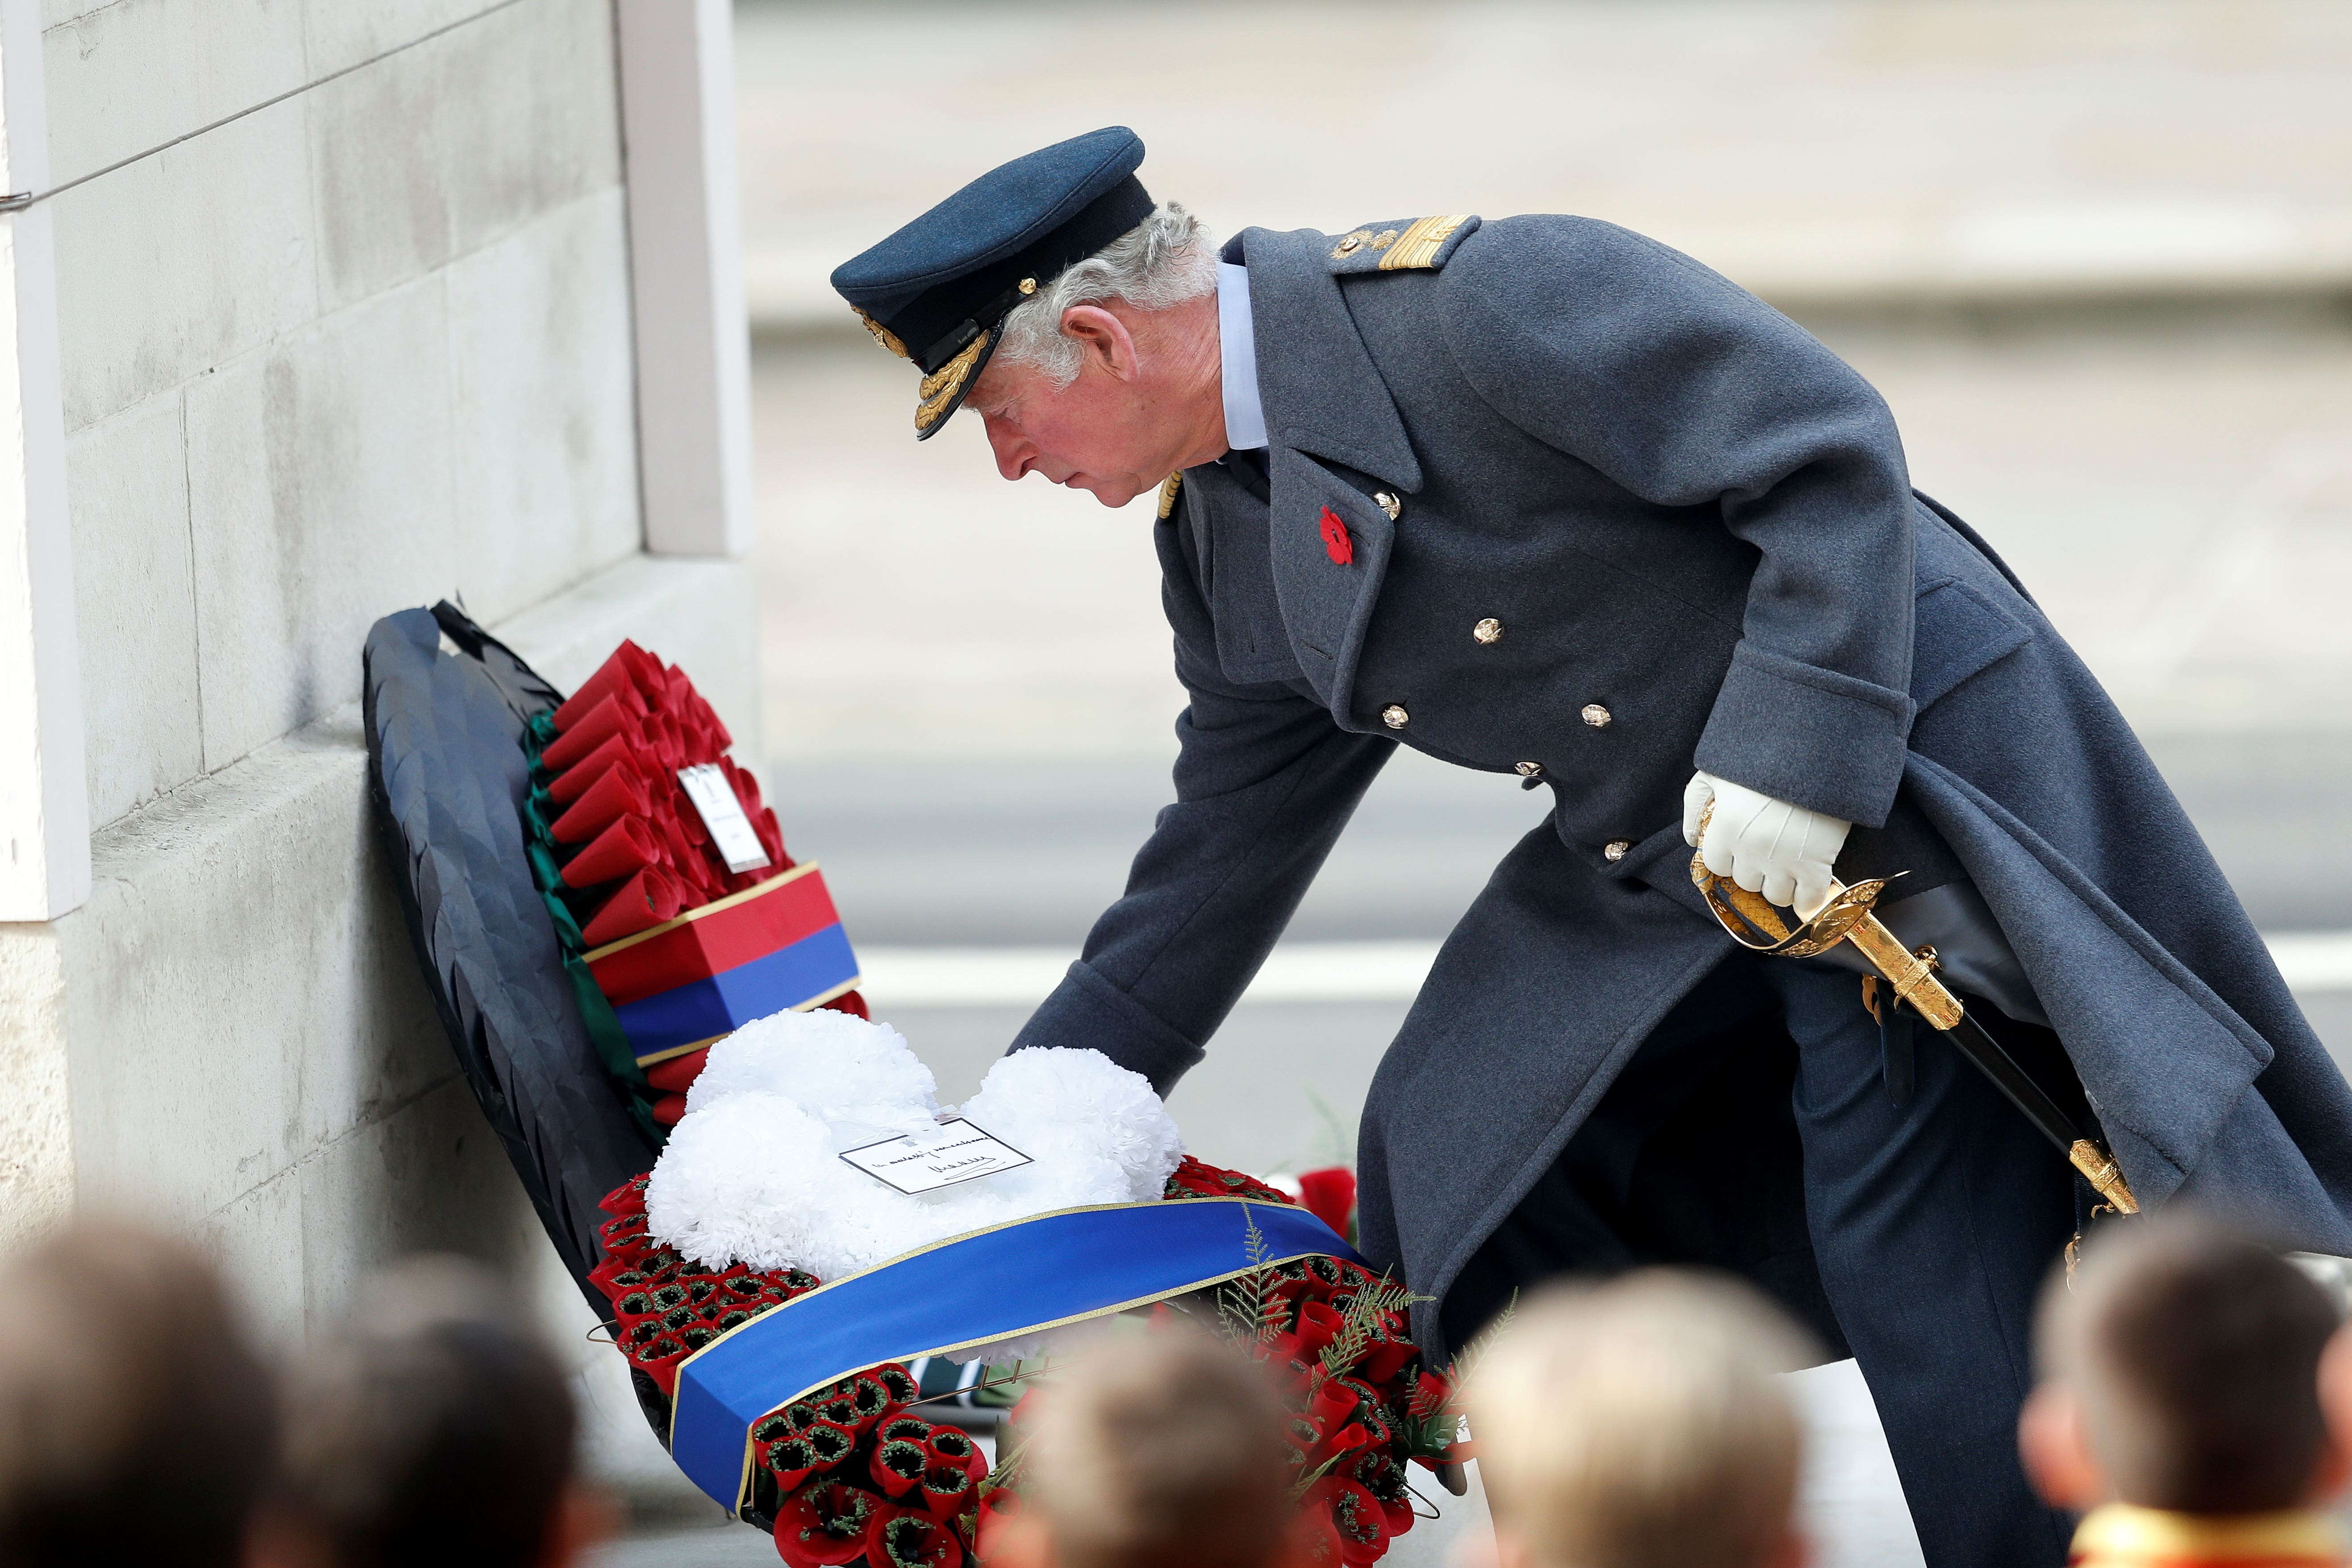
[56,710,454,1269]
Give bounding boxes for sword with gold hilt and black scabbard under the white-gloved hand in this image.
[1691,856,2140,1213]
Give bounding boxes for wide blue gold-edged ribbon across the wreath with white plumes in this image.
[670,1199,1362,1512]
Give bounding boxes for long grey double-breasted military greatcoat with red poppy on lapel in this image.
[1016,216,2352,1349]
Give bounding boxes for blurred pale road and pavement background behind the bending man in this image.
[592,0,2352,1561]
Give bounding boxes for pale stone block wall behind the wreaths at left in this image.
[0,0,760,1457]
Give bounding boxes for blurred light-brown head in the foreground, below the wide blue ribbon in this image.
[990,1333,1291,1568]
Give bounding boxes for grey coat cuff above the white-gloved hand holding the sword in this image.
[1696,642,1912,828]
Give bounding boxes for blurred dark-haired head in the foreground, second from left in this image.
[261,1258,604,1568]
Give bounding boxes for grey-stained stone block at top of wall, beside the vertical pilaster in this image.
[306,0,621,306]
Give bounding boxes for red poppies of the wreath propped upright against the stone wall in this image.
[522,642,866,1140]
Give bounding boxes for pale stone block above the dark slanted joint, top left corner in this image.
[42,0,308,181]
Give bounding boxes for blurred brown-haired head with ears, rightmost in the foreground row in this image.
[2037,1210,2338,1514]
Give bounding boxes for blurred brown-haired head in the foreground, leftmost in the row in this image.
[0,1225,271,1568]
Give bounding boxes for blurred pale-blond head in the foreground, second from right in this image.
[1468,1269,1811,1568]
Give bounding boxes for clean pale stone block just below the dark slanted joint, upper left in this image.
[52,99,317,433]
